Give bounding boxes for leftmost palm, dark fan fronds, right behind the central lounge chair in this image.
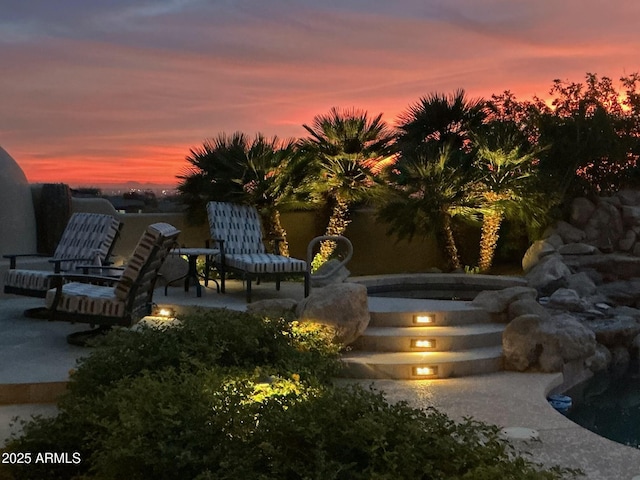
[178,132,296,255]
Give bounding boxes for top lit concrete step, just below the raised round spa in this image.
[369,297,492,327]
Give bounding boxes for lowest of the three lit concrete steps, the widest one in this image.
[342,347,502,380]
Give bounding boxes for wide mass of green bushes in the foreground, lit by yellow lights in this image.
[0,311,580,480]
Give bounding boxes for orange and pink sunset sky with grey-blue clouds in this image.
[0,0,640,186]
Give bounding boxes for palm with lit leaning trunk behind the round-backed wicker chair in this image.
[300,107,393,268]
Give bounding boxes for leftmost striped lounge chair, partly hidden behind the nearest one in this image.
[4,213,121,298]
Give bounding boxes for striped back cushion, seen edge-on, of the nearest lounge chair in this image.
[115,223,180,300]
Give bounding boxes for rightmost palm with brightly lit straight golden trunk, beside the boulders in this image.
[472,121,553,272]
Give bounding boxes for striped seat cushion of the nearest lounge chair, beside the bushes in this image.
[46,282,126,318]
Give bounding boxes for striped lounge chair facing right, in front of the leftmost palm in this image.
[207,202,309,303]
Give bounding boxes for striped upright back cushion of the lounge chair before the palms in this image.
[207,202,266,254]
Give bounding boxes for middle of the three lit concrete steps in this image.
[352,323,505,352]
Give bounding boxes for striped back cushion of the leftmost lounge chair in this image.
[53,213,120,271]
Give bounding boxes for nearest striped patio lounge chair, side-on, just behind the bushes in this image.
[46,223,180,336]
